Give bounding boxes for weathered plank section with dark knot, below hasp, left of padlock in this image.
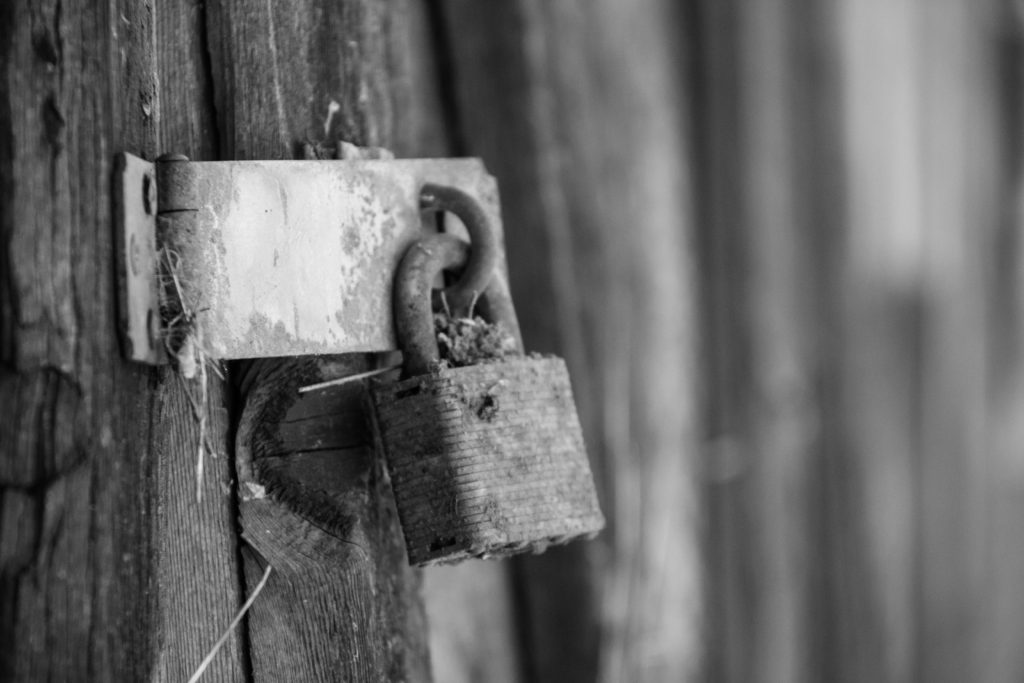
[237,355,429,681]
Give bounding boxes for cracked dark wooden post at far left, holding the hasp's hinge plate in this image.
[0,2,244,681]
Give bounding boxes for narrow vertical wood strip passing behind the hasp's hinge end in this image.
[152,0,249,681]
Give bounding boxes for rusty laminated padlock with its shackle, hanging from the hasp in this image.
[372,229,604,566]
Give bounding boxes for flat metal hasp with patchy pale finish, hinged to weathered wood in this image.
[114,154,505,364]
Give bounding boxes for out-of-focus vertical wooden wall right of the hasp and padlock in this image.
[428,0,1024,683]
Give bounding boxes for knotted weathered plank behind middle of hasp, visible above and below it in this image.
[208,0,444,680]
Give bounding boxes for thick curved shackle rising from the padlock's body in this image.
[394,234,522,377]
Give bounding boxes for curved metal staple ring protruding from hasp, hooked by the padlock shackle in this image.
[420,182,498,308]
